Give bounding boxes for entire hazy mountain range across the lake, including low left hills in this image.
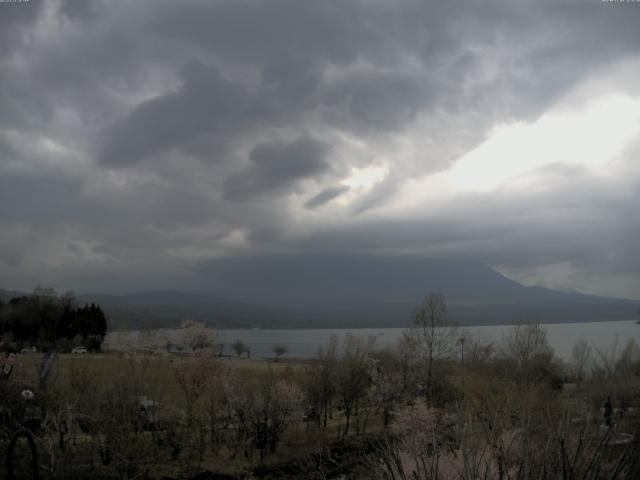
[0,255,640,328]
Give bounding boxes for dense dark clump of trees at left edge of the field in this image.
[0,287,107,351]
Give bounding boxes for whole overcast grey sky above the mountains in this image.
[0,0,640,299]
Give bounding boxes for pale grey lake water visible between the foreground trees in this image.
[218,320,640,360]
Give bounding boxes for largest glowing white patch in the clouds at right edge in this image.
[448,96,640,191]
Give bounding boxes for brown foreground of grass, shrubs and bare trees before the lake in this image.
[0,293,640,480]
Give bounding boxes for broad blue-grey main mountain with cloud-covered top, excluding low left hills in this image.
[200,255,638,326]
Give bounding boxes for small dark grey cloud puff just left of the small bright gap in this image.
[224,136,331,201]
